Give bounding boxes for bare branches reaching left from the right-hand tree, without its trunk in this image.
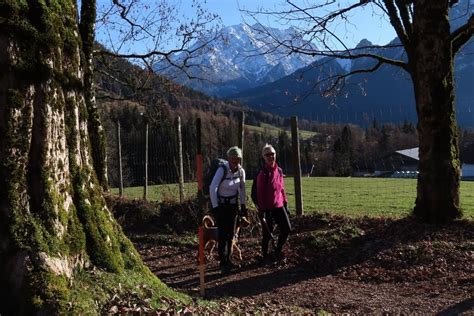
[237,0,412,96]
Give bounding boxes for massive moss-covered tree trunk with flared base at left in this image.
[0,0,145,313]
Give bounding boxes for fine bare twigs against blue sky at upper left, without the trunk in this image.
[94,0,221,79]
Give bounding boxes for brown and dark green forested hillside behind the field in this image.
[92,50,474,186]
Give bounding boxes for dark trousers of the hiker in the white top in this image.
[214,204,239,264]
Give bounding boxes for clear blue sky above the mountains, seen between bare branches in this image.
[96,0,395,53]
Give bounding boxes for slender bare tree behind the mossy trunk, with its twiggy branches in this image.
[84,0,220,187]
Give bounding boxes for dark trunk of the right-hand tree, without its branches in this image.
[411,0,461,222]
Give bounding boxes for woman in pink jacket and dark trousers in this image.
[255,144,291,260]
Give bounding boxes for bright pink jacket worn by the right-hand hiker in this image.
[257,163,287,210]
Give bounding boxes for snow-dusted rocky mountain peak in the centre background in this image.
[155,24,315,97]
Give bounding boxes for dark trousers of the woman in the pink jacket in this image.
[262,207,291,257]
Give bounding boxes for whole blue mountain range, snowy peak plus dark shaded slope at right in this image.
[154,0,474,127]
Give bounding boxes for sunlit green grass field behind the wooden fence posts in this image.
[112,177,474,219]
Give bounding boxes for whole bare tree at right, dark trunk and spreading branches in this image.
[246,0,474,222]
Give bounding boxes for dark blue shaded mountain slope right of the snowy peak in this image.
[231,0,474,127]
